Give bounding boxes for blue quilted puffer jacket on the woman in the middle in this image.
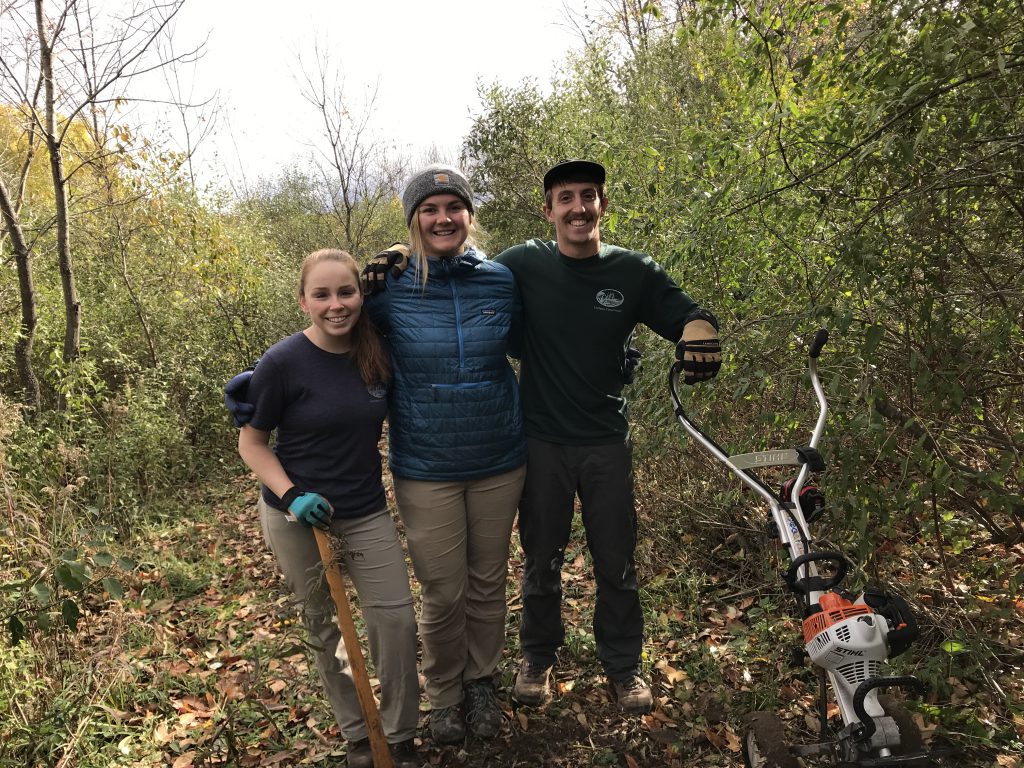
[366,249,526,480]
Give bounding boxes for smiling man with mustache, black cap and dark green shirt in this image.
[496,160,722,714]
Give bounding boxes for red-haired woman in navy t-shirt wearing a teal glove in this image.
[239,250,420,768]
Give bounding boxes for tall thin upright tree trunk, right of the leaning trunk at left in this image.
[36,0,82,362]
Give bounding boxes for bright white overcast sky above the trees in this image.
[125,0,600,187]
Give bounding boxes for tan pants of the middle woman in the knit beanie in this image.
[394,467,526,709]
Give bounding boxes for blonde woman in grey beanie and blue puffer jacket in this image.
[367,166,526,743]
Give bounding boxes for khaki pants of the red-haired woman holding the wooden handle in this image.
[259,499,420,743]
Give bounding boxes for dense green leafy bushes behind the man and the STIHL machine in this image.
[465,2,1024,556]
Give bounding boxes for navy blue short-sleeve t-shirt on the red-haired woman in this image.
[249,333,387,517]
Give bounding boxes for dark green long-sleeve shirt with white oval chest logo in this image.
[496,240,697,445]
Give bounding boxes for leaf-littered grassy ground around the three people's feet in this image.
[0,468,1024,768]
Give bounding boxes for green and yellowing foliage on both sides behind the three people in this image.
[0,0,1024,755]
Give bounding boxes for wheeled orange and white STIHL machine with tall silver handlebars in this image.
[669,330,938,768]
